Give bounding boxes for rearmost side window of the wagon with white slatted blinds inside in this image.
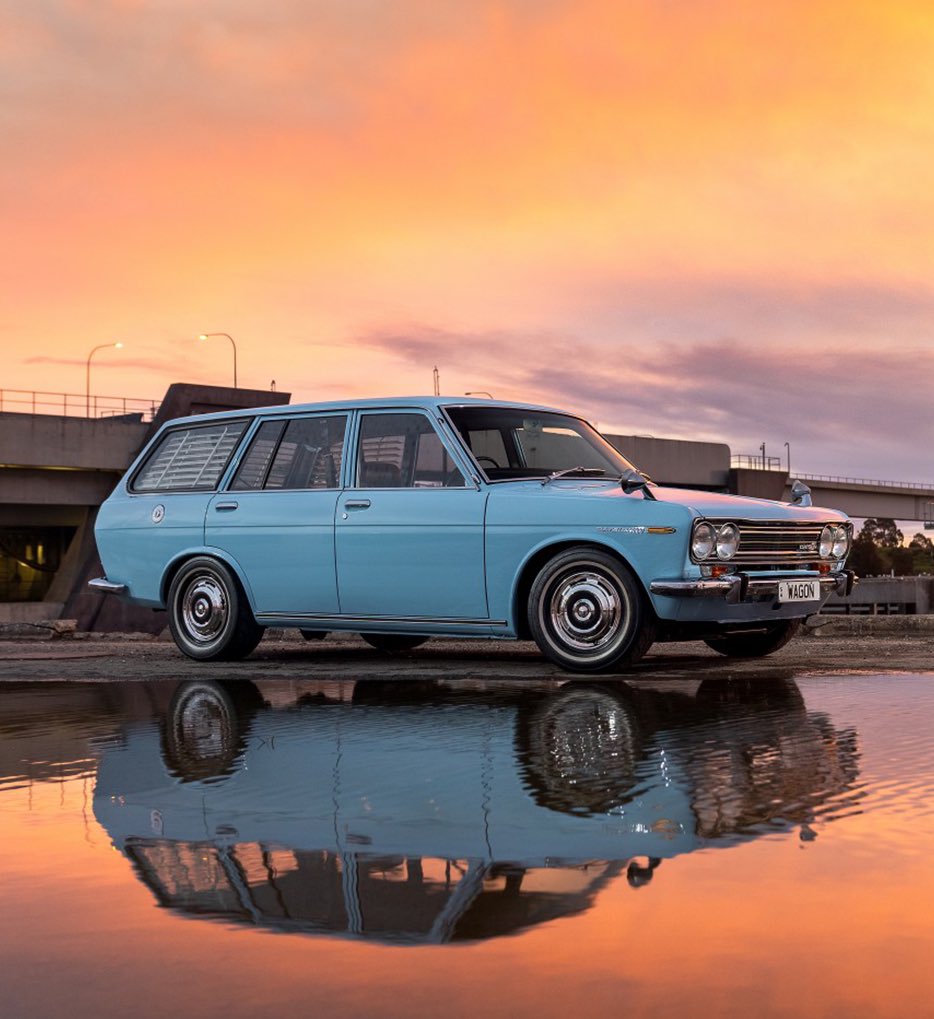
[130,421,248,492]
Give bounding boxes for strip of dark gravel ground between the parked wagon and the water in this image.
[0,615,934,683]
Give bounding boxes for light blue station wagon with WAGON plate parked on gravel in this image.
[91,396,853,673]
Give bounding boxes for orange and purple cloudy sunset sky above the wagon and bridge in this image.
[0,0,934,481]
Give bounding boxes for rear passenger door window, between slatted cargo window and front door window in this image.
[230,415,347,491]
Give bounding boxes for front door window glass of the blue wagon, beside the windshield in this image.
[356,414,465,488]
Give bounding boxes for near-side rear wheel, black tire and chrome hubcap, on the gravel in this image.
[168,555,264,661]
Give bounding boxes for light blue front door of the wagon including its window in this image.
[335,411,489,623]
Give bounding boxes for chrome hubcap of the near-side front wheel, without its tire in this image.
[548,570,628,652]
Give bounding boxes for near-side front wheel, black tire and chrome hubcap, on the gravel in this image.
[529,546,655,673]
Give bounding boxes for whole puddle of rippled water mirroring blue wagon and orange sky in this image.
[0,677,934,1017]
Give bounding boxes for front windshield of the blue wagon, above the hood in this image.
[447,407,633,481]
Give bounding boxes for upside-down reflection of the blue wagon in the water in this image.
[94,681,859,944]
